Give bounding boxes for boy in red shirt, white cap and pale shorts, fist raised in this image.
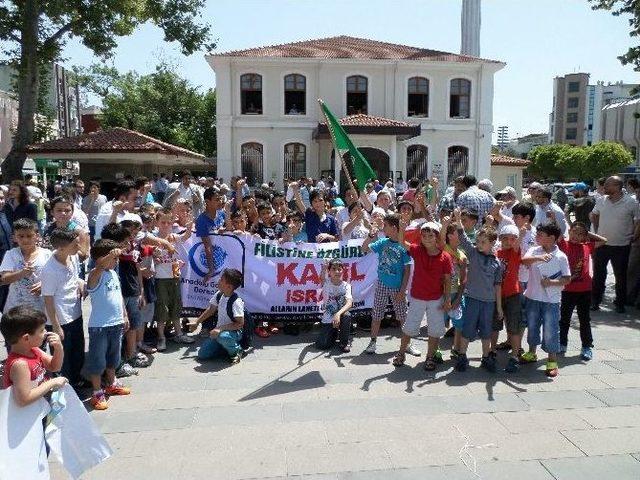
[393,219,453,371]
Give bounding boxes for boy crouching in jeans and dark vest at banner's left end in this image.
[195,268,244,365]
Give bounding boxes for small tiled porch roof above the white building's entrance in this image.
[314,113,421,140]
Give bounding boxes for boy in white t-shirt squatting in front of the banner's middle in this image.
[315,259,353,353]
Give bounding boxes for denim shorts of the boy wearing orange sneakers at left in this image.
[84,324,124,375]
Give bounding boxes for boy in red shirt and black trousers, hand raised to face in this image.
[558,222,607,360]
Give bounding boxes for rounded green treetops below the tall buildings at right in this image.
[527,142,633,181]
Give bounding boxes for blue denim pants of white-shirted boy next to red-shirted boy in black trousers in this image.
[524,298,560,353]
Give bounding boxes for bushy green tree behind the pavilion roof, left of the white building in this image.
[78,63,216,156]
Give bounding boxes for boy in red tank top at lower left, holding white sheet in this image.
[0,306,67,407]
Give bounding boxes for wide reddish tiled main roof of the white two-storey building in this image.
[211,35,502,64]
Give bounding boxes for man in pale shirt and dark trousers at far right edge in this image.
[591,176,640,313]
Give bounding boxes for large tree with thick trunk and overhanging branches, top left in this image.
[0,0,215,181]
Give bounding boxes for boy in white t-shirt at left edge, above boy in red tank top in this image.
[0,218,51,313]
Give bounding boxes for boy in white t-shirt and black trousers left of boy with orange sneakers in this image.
[40,228,84,385]
